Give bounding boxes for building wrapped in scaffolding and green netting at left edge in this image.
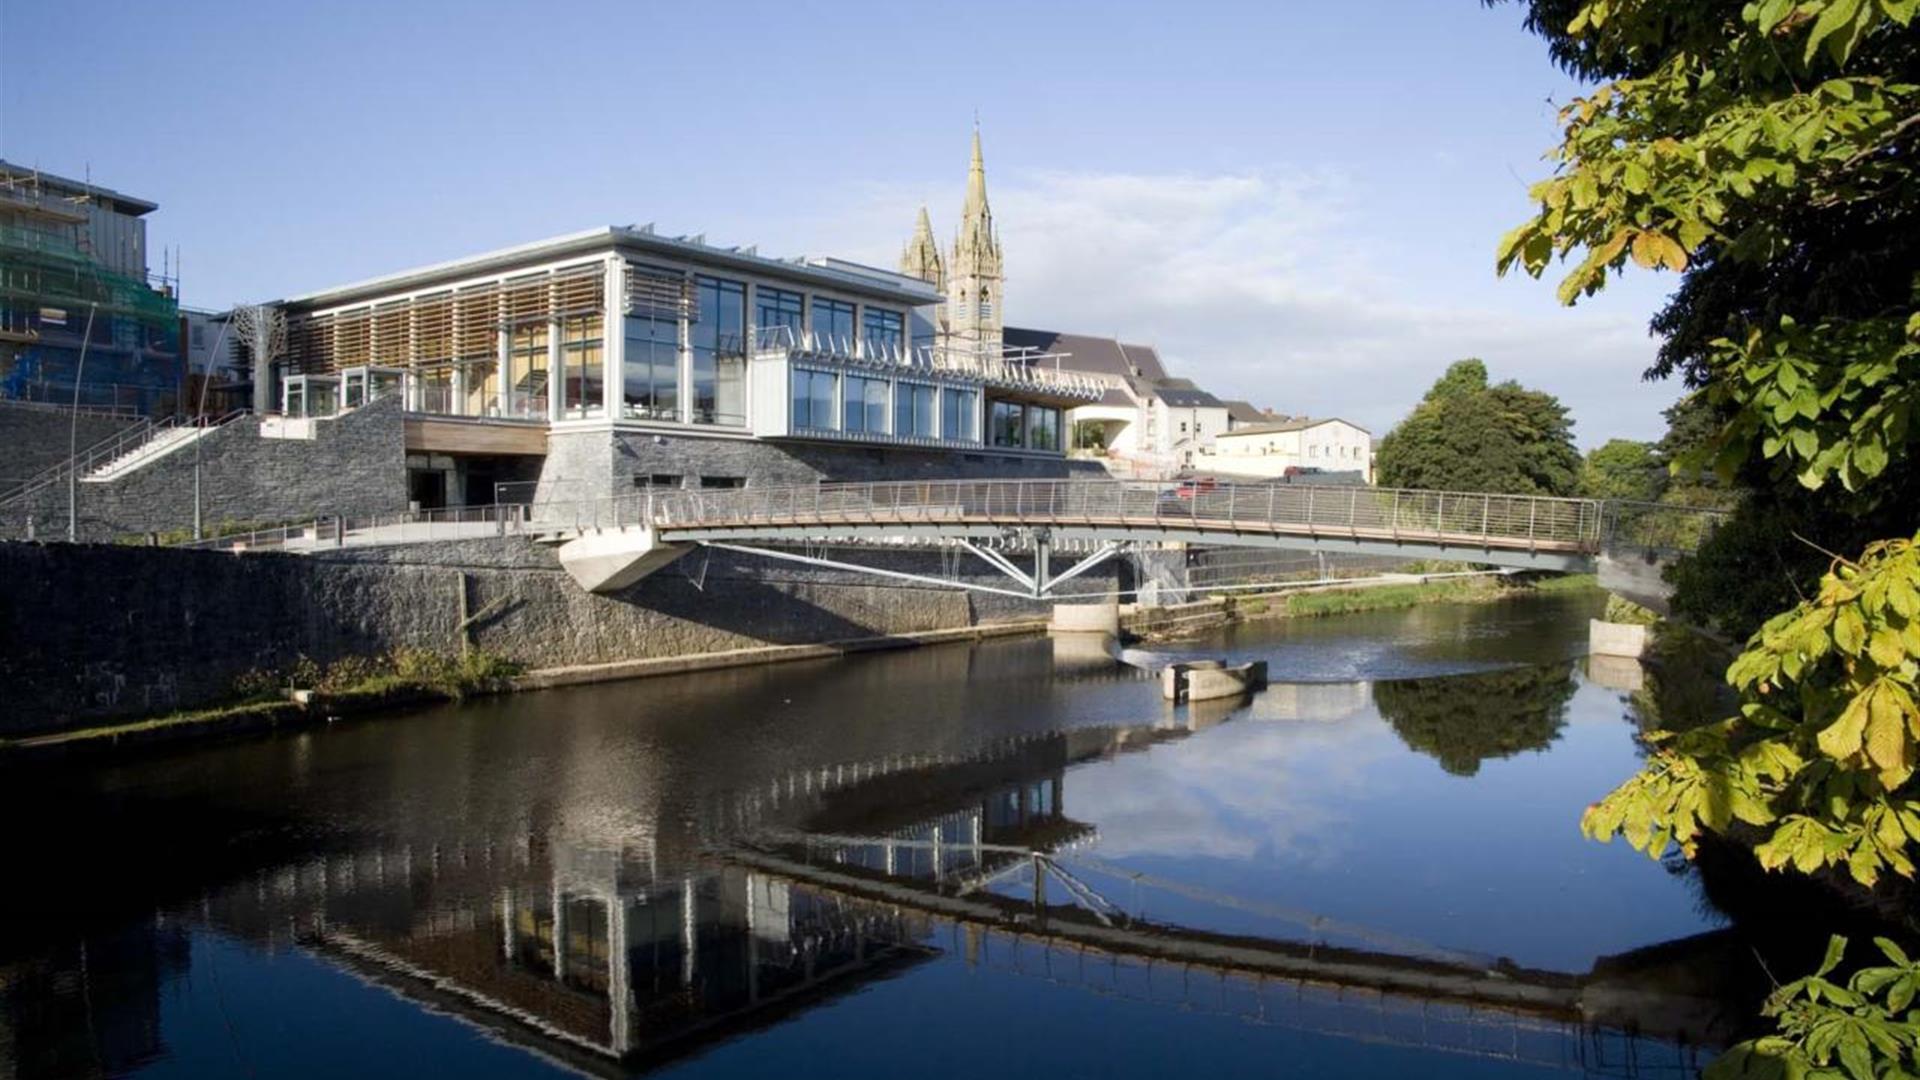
[0,161,184,413]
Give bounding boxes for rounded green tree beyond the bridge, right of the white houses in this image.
[1377,359,1580,496]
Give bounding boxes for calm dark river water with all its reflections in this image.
[0,598,1789,1076]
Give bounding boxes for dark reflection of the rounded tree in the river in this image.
[1373,663,1574,776]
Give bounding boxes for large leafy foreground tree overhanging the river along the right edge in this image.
[1496,0,1920,1080]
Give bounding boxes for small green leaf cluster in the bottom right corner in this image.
[1705,938,1920,1080]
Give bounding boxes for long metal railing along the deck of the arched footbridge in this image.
[637,480,1607,550]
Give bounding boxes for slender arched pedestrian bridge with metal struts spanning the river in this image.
[172,479,1720,603]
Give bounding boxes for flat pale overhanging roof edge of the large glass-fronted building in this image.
[278,225,941,307]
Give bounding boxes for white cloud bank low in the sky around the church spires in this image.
[812,163,1676,446]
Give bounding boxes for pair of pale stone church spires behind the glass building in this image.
[900,127,1006,354]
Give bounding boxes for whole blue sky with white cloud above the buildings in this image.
[0,0,1678,448]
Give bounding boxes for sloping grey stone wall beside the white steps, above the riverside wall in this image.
[0,398,407,542]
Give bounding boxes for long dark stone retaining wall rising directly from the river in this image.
[0,538,1131,734]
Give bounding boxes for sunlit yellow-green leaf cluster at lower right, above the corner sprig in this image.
[1580,538,1920,886]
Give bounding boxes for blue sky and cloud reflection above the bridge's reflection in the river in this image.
[1062,672,1707,970]
